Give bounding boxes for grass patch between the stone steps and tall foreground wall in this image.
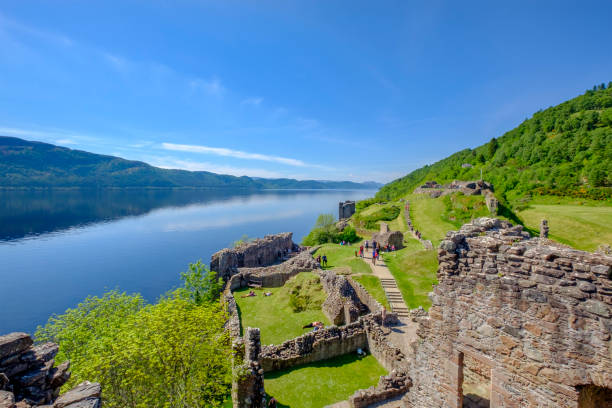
[383,238,438,309]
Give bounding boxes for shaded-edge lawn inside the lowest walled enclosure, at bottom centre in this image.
[265,354,387,408]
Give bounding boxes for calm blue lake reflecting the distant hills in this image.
[0,190,374,334]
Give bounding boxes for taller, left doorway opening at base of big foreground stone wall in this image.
[460,353,491,408]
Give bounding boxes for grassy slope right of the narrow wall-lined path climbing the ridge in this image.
[407,194,457,247]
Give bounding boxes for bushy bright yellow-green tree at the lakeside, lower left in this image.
[36,268,231,408]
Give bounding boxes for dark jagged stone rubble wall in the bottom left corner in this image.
[0,333,101,408]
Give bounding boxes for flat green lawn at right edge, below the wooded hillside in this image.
[518,204,612,251]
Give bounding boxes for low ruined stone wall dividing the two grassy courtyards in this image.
[259,320,367,372]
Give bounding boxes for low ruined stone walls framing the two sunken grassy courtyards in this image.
[213,234,410,407]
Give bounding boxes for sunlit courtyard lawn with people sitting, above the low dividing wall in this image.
[234,272,330,344]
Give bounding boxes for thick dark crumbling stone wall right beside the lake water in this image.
[210,232,298,281]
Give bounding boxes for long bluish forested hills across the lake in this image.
[0,136,381,190]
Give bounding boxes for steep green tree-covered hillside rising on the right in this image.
[376,82,612,202]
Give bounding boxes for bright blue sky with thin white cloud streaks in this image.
[0,0,612,182]
